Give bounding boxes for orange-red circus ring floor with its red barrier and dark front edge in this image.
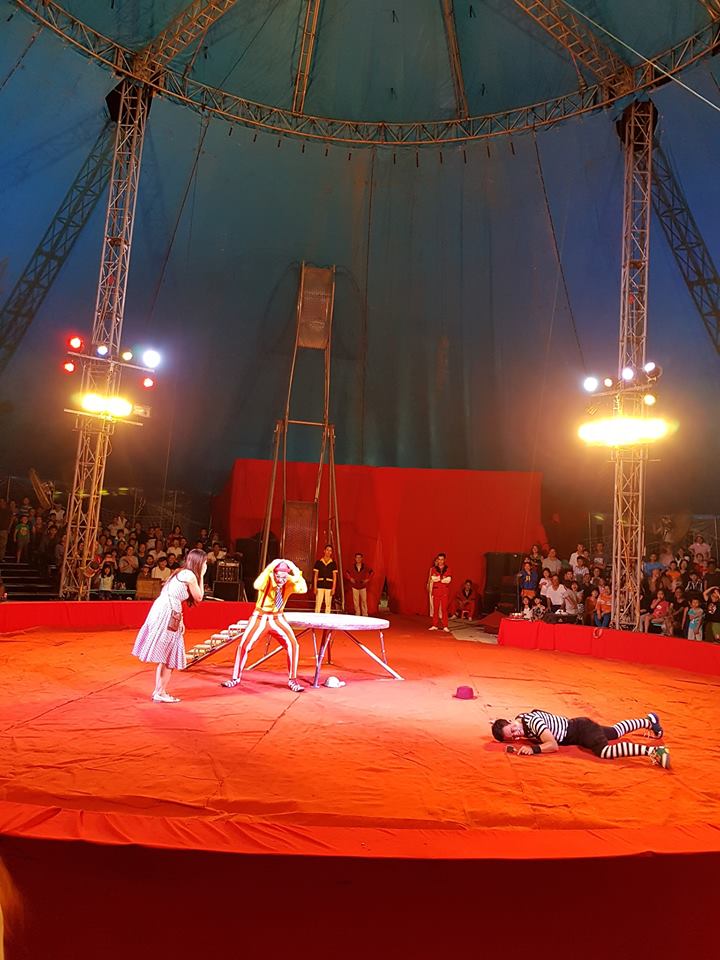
[0,603,720,960]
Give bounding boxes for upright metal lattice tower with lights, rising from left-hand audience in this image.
[60,80,151,600]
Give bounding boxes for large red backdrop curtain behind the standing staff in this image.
[213,460,545,613]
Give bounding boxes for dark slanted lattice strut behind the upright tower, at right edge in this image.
[653,141,720,353]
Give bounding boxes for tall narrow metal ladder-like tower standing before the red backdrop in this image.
[260,263,345,609]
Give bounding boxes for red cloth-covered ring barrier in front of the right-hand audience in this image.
[498,617,720,676]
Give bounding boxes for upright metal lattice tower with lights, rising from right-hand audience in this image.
[611,100,656,630]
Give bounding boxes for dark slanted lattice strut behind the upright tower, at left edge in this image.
[0,123,114,374]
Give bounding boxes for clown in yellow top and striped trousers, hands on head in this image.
[222,559,307,693]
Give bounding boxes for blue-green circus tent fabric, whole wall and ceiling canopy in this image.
[0,0,720,513]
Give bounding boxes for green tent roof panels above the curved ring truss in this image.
[21,0,709,122]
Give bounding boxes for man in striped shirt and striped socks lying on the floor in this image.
[492,710,670,770]
